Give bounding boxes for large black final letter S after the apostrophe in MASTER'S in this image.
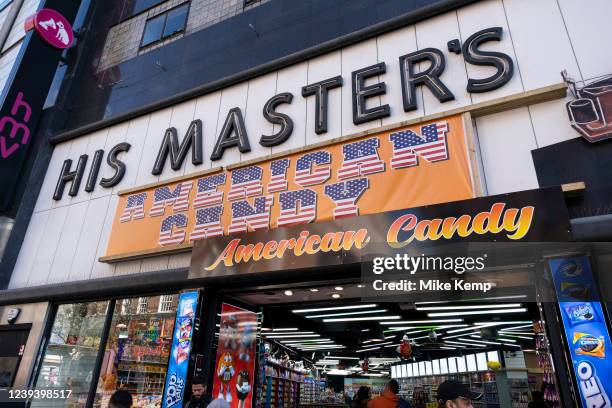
[461,27,514,93]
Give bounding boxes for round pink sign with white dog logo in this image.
[25,9,74,49]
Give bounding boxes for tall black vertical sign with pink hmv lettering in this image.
[0,0,81,214]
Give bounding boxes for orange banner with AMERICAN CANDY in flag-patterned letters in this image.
[102,116,474,262]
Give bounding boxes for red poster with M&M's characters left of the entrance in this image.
[213,303,257,408]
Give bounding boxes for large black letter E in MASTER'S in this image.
[351,62,391,125]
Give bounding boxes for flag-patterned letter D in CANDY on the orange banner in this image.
[276,188,317,227]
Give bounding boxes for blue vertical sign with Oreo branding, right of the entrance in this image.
[549,256,612,408]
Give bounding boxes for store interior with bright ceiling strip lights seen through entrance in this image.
[222,282,559,408]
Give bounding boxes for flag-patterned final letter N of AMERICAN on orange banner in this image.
[389,122,448,169]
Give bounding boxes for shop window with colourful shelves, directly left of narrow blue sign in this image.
[93,295,178,408]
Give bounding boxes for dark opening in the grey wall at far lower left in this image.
[0,324,31,389]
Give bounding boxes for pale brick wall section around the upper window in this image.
[98,0,270,71]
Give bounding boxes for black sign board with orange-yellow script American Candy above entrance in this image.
[189,187,571,278]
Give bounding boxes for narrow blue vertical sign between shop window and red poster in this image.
[162,291,198,408]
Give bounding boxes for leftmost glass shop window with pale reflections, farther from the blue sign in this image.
[31,302,109,408]
